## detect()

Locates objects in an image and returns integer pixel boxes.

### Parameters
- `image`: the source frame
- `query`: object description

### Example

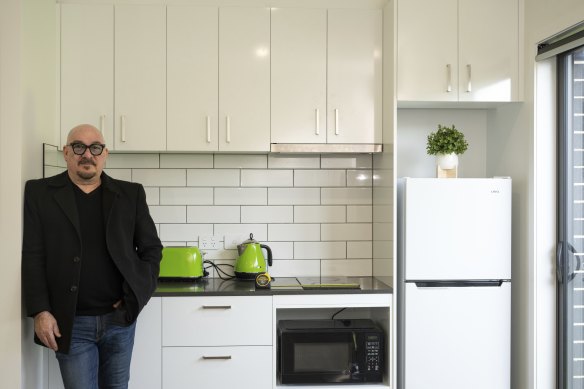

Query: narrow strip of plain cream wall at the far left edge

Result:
[0,0,22,388]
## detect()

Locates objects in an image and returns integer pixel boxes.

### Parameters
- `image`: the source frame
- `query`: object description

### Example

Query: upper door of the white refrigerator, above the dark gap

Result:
[400,178,511,280]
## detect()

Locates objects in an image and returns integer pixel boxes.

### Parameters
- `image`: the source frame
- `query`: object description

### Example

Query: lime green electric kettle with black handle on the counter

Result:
[234,234,272,280]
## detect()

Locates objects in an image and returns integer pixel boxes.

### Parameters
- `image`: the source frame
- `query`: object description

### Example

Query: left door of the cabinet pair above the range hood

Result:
[271,8,326,143]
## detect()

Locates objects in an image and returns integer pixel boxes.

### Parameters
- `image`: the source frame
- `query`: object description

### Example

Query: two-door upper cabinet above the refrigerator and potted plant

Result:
[397,0,519,102]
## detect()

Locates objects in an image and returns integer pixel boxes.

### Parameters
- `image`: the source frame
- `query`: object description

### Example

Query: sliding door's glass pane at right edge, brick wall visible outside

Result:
[556,46,584,389]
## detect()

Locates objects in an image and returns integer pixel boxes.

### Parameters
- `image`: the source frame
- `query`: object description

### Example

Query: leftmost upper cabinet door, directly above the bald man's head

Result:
[61,4,114,148]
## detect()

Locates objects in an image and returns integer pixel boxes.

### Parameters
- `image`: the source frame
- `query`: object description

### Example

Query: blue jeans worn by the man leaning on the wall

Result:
[55,313,136,389]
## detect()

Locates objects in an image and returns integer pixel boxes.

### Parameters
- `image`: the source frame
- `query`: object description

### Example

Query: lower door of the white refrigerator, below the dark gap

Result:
[398,282,511,389]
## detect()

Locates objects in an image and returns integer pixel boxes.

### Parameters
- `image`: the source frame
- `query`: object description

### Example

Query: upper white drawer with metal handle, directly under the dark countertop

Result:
[162,296,272,346]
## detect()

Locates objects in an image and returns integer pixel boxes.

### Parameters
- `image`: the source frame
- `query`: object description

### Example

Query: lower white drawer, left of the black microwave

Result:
[162,346,272,389]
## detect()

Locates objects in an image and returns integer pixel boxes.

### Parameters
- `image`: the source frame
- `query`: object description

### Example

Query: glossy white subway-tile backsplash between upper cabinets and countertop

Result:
[43,153,374,277]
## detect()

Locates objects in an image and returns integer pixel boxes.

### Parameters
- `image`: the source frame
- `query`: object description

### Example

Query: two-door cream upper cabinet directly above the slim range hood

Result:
[271,8,382,143]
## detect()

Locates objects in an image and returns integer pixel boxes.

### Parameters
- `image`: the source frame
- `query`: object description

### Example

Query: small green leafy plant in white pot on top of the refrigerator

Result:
[426,124,468,170]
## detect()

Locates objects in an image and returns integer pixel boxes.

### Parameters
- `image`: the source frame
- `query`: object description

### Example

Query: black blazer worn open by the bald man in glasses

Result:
[22,171,162,353]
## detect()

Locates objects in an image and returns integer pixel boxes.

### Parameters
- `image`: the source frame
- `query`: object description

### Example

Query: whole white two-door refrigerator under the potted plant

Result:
[397,178,511,389]
